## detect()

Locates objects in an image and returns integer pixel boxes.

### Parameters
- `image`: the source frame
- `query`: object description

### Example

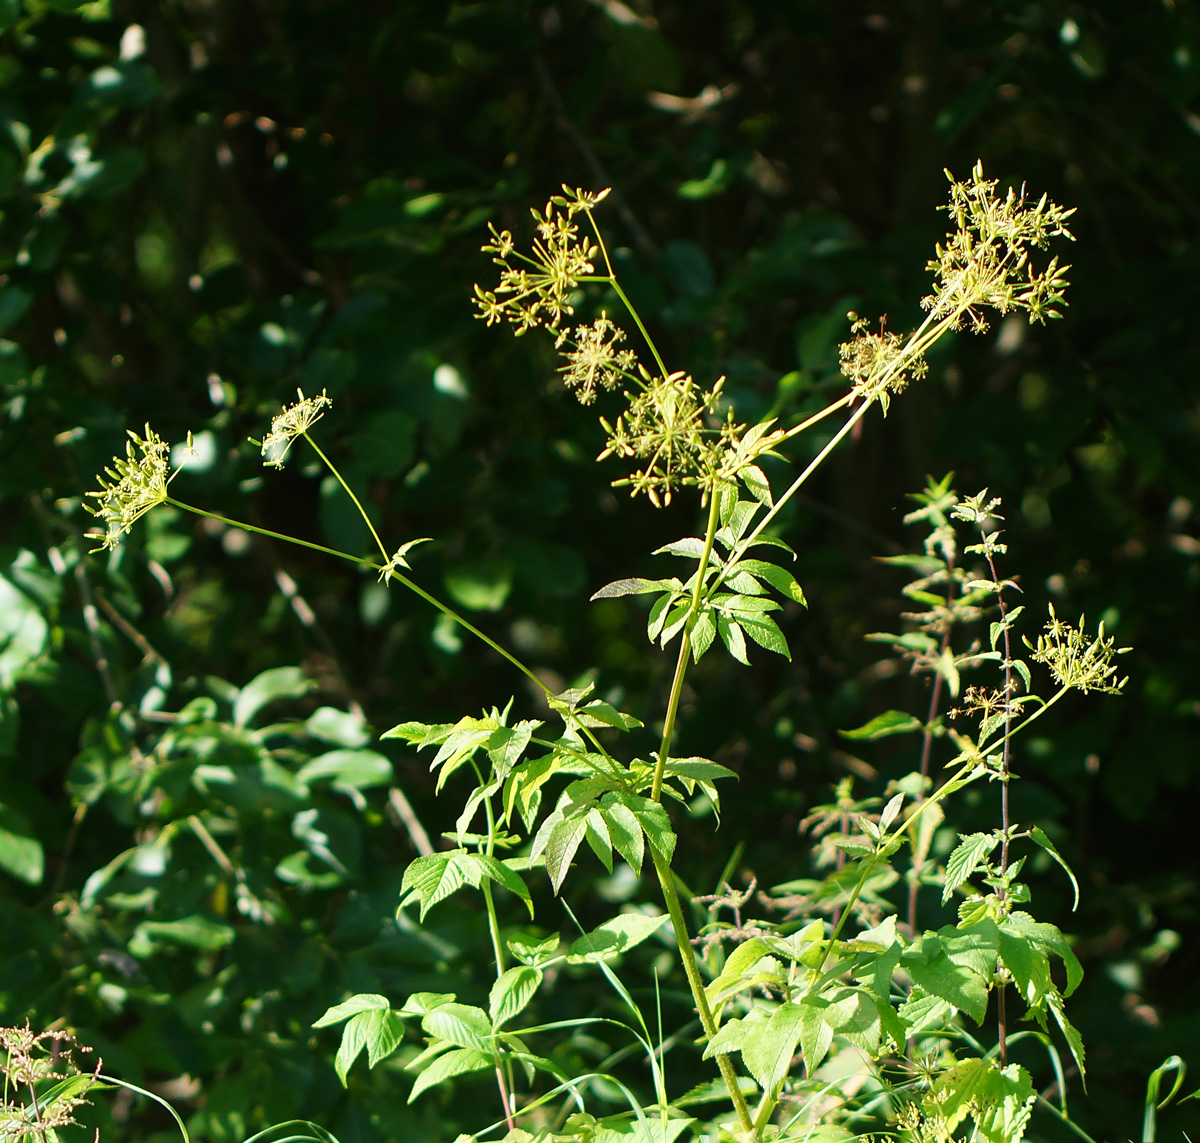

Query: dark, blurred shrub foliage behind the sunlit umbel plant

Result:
[0,0,1200,1143]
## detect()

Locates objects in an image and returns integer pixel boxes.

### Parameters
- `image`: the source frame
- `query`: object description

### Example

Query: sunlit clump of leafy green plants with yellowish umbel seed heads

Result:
[79,164,1123,1143]
